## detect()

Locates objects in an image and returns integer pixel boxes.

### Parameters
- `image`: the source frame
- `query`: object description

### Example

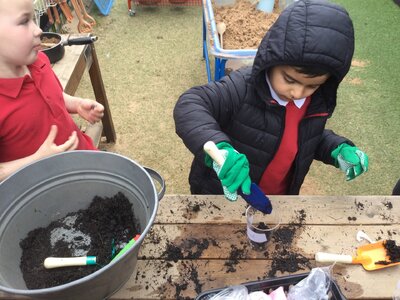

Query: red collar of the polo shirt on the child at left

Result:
[0,55,46,98]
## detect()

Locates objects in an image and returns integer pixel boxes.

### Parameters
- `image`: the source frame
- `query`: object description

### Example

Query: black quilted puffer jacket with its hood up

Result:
[174,0,354,195]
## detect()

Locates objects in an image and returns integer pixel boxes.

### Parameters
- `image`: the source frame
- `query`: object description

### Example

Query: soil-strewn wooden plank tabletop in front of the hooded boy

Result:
[111,195,400,300]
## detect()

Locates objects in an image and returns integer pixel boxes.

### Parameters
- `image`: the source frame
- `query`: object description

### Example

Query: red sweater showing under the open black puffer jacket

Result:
[259,97,310,195]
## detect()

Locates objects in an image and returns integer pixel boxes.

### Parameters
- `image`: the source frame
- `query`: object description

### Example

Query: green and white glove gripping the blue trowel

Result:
[205,142,251,200]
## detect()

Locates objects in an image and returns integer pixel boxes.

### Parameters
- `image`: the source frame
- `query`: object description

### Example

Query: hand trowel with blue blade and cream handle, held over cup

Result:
[203,141,272,214]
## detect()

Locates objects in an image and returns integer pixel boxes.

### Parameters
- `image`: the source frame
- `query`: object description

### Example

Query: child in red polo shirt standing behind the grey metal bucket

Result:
[0,0,104,180]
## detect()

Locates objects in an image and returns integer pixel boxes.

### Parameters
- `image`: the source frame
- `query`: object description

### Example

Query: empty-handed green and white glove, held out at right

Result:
[331,143,368,181]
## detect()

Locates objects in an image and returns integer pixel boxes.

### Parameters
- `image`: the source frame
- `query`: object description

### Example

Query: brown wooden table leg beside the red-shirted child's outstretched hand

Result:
[89,44,117,143]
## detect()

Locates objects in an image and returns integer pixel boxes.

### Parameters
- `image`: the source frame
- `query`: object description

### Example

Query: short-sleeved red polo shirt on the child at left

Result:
[0,52,96,162]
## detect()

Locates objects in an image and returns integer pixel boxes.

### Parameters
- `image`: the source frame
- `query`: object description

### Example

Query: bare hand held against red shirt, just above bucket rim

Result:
[34,125,79,159]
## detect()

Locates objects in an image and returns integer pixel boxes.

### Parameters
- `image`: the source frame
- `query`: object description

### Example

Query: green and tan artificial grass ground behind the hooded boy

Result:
[77,0,400,195]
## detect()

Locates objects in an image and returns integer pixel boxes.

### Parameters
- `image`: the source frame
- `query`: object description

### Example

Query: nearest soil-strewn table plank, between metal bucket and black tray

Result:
[111,260,305,300]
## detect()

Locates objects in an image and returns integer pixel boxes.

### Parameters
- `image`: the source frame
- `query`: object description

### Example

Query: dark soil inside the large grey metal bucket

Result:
[20,193,140,289]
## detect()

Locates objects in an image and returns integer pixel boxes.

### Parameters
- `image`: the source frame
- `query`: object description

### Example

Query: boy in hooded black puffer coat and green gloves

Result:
[174,0,368,195]
